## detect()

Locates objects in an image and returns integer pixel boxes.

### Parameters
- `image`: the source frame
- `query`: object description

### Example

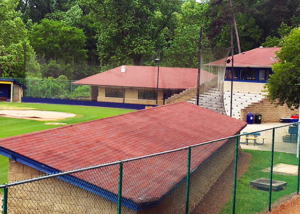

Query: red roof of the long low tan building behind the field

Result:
[73,63,217,89]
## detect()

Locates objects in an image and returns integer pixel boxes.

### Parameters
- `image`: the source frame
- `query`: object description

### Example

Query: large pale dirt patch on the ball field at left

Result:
[0,110,76,121]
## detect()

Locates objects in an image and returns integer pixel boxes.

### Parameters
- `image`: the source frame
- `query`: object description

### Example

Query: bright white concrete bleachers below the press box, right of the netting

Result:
[224,91,265,119]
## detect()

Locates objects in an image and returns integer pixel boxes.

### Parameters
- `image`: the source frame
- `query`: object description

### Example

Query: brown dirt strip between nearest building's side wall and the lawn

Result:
[191,152,252,214]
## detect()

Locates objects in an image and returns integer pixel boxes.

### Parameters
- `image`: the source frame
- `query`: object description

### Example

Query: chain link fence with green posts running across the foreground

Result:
[0,123,299,214]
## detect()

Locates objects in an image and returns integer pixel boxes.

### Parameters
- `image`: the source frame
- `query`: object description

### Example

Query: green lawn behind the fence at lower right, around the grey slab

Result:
[220,150,298,214]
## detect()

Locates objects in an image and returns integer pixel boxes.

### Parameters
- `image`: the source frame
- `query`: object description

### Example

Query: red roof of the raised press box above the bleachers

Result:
[208,47,281,68]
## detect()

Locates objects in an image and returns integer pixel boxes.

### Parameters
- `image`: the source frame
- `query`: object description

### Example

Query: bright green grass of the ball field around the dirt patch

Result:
[0,103,135,184]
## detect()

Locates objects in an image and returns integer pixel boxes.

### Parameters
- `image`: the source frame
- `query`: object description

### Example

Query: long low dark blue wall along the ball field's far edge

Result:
[22,97,155,110]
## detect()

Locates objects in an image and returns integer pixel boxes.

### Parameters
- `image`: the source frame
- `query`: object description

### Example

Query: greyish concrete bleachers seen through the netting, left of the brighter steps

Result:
[188,88,226,114]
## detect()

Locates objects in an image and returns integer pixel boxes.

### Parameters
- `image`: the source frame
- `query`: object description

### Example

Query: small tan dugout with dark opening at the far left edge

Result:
[0,78,26,102]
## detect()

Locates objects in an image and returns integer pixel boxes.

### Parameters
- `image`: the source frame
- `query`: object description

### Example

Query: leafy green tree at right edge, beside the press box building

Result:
[267,28,300,109]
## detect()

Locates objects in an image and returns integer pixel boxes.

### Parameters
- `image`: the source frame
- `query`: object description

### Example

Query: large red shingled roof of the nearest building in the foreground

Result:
[0,103,246,203]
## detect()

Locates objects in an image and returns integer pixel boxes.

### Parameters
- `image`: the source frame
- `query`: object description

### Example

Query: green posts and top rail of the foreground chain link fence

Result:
[0,123,300,214]
